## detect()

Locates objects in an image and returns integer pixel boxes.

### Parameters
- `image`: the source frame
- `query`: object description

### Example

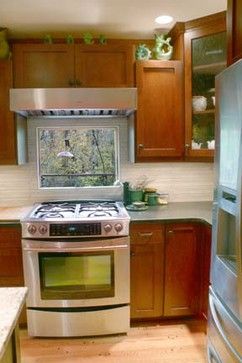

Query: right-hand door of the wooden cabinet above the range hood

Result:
[75,44,133,87]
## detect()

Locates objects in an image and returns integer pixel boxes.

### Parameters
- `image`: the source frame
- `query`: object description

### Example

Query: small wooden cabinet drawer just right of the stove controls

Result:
[130,223,164,244]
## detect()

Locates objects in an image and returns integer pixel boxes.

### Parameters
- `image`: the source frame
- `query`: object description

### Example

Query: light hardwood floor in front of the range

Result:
[20,320,206,363]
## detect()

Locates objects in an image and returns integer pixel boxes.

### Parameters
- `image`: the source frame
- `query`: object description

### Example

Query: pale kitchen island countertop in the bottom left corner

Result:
[0,287,27,359]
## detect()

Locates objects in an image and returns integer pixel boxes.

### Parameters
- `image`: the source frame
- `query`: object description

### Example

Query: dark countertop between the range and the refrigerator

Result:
[128,202,212,225]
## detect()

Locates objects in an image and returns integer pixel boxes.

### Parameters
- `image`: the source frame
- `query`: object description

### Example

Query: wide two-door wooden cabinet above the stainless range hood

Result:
[13,43,133,88]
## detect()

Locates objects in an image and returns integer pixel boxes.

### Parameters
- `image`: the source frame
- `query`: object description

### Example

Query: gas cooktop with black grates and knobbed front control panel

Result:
[21,200,130,238]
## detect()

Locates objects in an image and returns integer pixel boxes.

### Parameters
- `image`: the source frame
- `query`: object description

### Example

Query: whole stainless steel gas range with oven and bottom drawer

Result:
[21,200,130,337]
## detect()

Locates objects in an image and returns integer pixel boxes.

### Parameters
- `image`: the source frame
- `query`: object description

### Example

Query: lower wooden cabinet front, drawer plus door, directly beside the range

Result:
[130,223,164,319]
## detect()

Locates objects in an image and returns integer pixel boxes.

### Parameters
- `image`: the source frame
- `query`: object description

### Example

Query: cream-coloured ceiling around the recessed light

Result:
[0,0,227,39]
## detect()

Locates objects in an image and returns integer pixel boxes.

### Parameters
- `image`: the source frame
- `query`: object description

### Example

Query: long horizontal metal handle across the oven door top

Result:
[24,244,129,253]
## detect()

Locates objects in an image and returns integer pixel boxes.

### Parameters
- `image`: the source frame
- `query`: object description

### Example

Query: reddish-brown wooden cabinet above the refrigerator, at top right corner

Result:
[227,0,242,65]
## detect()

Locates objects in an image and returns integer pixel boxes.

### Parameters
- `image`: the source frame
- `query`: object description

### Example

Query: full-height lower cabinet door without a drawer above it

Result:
[164,224,200,316]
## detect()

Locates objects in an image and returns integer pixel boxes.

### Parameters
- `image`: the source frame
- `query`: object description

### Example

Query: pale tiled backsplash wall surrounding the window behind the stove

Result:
[0,119,213,206]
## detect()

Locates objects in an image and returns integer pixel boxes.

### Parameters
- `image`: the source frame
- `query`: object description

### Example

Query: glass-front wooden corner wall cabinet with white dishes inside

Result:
[185,19,227,161]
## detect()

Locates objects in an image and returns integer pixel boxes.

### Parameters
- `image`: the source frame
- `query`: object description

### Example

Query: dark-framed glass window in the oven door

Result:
[39,251,114,300]
